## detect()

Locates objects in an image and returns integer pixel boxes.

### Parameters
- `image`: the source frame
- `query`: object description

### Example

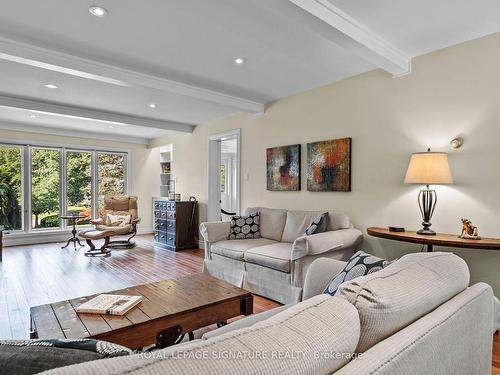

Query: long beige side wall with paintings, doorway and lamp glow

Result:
[153,34,500,295]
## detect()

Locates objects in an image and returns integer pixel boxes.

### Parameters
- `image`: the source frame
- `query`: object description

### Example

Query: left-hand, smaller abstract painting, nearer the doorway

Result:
[266,145,300,191]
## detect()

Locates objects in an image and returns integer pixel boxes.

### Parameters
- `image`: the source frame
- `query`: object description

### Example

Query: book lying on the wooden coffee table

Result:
[75,294,142,315]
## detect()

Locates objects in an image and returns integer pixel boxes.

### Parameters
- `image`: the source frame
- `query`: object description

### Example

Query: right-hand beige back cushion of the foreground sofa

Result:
[335,253,469,352]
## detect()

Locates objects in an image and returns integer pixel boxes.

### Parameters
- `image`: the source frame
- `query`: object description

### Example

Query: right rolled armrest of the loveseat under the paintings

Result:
[291,228,363,260]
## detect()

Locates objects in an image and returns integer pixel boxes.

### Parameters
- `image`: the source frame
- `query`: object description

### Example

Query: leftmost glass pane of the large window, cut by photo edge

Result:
[0,145,23,230]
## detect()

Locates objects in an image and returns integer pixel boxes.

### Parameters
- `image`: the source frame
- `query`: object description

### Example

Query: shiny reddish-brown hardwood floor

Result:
[0,235,500,375]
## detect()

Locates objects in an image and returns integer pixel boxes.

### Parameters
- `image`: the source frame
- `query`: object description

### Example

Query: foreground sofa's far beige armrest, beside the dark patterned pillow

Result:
[302,258,346,301]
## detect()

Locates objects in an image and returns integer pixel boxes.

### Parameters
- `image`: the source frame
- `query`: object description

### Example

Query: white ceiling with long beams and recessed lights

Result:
[0,0,500,142]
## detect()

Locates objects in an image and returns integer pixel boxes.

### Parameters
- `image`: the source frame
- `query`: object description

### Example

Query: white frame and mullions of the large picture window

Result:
[0,138,131,236]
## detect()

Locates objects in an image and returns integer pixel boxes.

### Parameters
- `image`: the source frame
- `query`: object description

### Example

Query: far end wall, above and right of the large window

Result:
[0,130,160,232]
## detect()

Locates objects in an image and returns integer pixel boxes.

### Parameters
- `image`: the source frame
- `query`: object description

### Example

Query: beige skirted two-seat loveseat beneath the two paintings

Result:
[200,207,363,304]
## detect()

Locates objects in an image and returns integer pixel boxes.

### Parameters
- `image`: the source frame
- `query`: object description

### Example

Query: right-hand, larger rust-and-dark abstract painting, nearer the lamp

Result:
[307,138,351,191]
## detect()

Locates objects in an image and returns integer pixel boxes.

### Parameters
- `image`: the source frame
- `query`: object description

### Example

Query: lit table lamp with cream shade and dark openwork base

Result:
[405,148,453,235]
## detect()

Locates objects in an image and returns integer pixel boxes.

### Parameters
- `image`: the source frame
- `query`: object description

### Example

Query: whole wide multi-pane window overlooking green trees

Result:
[0,144,128,232]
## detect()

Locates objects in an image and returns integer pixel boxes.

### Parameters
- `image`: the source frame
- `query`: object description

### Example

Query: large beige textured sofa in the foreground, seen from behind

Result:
[43,253,497,375]
